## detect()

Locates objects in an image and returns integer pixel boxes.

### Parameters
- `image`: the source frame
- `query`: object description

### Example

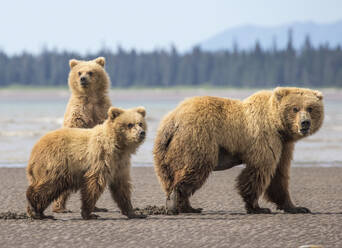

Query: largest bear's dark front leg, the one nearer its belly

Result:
[237,165,272,214]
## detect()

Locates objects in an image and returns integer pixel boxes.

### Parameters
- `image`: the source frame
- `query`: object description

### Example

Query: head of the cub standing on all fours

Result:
[106,107,147,149]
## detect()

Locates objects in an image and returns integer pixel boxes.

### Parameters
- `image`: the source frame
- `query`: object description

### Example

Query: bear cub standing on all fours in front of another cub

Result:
[26,107,147,219]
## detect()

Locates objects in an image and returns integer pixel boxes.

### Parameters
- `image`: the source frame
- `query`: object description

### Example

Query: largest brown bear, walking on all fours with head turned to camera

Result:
[154,87,324,213]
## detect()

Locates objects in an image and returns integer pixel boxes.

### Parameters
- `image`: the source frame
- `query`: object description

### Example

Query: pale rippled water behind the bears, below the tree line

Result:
[0,89,342,167]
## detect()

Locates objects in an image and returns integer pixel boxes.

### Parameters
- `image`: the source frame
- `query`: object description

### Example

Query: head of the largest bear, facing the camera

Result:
[273,87,324,140]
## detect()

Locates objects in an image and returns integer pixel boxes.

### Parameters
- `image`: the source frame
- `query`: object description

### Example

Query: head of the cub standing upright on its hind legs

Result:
[69,57,109,95]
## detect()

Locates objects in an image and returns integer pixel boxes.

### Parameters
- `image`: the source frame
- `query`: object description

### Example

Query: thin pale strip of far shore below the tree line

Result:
[0,86,342,101]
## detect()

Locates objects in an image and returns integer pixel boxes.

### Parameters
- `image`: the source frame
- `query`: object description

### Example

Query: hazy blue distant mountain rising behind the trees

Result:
[198,20,342,51]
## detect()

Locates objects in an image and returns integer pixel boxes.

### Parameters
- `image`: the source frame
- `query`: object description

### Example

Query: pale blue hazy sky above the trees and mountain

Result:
[0,0,342,54]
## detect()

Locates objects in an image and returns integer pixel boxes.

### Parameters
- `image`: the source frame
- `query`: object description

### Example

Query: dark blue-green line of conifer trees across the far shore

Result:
[0,35,342,87]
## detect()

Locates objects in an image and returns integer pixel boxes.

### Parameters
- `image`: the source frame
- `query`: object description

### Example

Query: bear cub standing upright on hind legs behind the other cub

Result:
[52,57,111,213]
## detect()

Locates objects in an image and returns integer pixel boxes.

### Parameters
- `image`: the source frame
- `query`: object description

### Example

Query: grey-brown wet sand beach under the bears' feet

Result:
[0,167,342,247]
